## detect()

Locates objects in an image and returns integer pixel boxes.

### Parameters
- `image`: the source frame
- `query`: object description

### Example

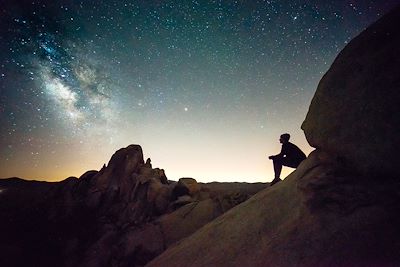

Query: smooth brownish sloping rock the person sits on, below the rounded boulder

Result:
[146,150,400,267]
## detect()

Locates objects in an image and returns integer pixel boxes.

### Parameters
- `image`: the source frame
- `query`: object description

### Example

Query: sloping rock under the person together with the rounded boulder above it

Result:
[146,7,400,267]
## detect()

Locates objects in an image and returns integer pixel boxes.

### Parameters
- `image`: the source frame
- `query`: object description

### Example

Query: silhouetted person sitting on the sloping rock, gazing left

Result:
[269,133,306,185]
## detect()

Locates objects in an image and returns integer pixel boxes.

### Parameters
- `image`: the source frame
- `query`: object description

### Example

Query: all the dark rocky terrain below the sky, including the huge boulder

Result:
[0,4,400,267]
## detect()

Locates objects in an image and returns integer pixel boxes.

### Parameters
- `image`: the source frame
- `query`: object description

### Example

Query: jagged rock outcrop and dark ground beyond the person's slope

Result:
[0,145,266,267]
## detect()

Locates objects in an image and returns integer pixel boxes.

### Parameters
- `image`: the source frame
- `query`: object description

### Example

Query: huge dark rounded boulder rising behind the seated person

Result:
[302,7,400,176]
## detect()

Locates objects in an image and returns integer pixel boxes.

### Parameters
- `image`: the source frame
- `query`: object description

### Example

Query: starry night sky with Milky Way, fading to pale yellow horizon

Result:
[0,0,399,182]
